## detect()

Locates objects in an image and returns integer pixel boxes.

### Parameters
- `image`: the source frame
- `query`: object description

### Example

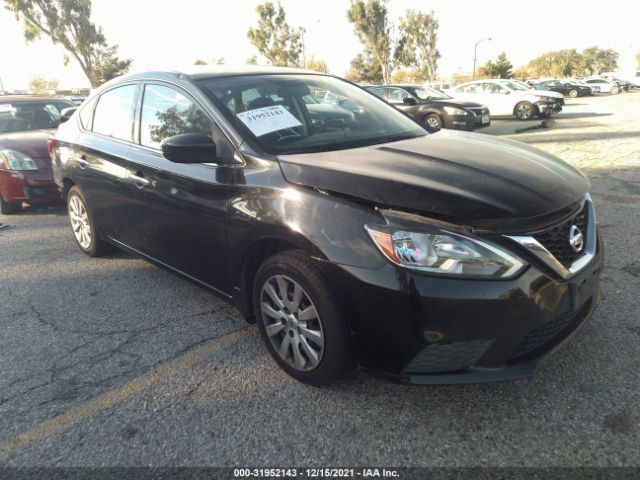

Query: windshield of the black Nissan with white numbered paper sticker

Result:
[200,74,426,154]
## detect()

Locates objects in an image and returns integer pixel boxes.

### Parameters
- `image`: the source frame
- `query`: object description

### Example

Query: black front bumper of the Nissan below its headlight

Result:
[320,231,603,384]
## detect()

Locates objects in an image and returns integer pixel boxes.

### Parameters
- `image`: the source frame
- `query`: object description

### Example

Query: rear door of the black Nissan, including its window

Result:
[69,82,139,243]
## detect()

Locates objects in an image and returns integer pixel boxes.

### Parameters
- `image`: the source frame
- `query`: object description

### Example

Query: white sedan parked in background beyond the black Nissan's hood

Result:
[447,80,563,120]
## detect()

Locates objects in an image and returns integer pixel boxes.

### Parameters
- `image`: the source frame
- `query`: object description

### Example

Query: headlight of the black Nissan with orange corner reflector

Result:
[365,225,525,278]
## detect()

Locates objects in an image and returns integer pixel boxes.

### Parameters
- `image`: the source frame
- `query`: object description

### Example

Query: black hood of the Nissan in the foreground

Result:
[278,130,589,226]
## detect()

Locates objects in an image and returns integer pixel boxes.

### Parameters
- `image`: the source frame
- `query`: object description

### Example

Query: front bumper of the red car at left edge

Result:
[0,170,60,203]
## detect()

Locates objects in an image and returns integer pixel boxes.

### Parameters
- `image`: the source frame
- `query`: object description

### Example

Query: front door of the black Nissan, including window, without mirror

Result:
[123,82,242,292]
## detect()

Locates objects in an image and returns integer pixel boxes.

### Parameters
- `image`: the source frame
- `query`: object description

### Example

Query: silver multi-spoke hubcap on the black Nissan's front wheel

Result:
[260,275,324,372]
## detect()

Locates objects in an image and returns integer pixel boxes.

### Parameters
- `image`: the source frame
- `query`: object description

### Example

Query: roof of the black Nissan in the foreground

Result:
[114,65,326,82]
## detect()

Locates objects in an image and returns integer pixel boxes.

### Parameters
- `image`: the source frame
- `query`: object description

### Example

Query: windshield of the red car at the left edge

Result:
[0,99,73,133]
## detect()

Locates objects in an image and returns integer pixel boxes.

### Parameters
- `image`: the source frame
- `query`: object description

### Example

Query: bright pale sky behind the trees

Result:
[0,0,640,90]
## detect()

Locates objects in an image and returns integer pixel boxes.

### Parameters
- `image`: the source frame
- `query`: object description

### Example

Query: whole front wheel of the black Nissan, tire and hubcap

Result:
[253,250,354,385]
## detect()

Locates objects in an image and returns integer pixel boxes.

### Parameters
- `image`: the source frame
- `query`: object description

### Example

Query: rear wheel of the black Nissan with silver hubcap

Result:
[67,186,113,257]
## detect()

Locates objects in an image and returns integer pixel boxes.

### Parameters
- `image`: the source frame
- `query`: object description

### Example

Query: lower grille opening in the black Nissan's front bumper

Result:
[509,299,593,362]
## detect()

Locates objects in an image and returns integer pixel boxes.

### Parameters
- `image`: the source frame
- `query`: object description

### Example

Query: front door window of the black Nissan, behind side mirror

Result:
[140,85,213,148]
